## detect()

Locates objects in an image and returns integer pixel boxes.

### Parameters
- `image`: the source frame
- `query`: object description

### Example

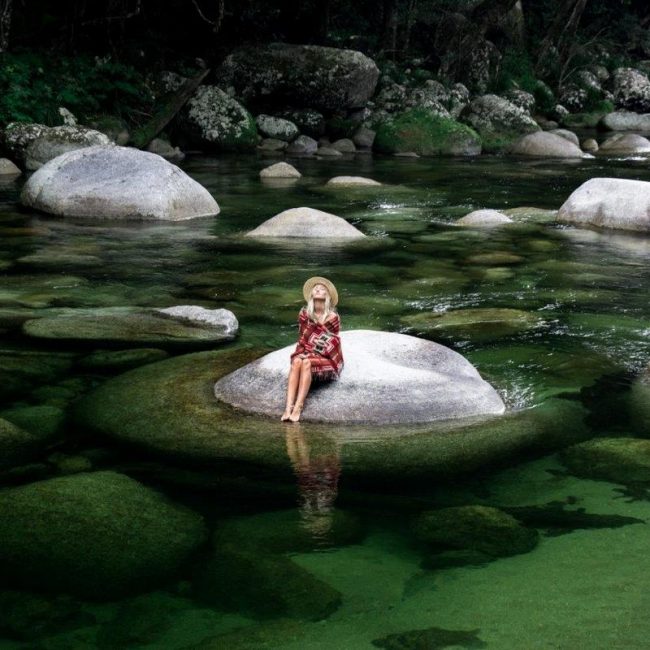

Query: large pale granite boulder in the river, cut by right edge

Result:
[557,178,650,232]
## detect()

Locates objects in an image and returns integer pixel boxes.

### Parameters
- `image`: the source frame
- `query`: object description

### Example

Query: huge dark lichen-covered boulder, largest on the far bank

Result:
[217,43,379,111]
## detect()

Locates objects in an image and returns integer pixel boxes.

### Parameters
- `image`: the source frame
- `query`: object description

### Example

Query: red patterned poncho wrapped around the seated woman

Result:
[291,307,343,381]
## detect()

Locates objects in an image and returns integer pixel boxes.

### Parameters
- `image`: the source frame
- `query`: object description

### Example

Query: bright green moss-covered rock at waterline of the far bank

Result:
[374,108,481,156]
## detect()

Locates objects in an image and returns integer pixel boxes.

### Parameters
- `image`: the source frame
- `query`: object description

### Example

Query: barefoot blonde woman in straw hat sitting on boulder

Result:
[280,277,343,422]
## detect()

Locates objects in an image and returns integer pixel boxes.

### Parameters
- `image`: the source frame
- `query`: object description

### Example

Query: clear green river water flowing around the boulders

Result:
[0,151,650,650]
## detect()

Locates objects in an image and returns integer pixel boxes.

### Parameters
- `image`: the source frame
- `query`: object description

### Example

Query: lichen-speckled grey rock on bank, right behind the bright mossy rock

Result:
[461,95,540,151]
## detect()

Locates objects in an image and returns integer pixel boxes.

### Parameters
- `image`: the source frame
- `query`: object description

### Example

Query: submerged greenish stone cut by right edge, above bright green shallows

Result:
[559,438,650,483]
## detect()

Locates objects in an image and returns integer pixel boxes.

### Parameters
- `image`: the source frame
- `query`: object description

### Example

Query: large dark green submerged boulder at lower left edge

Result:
[0,471,206,600]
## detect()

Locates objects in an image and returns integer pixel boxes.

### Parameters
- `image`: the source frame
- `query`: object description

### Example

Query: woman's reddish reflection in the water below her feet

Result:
[286,422,341,541]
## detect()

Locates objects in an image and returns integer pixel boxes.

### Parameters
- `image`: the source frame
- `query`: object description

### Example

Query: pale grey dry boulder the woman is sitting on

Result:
[214,330,505,423]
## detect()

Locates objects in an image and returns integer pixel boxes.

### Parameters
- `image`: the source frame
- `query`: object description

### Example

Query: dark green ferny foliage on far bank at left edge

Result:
[0,51,153,126]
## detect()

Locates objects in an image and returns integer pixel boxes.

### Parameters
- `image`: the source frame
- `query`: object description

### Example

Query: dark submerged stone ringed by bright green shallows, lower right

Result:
[413,505,539,557]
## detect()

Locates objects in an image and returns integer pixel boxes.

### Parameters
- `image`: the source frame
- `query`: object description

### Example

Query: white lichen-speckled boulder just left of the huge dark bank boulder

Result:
[178,86,257,151]
